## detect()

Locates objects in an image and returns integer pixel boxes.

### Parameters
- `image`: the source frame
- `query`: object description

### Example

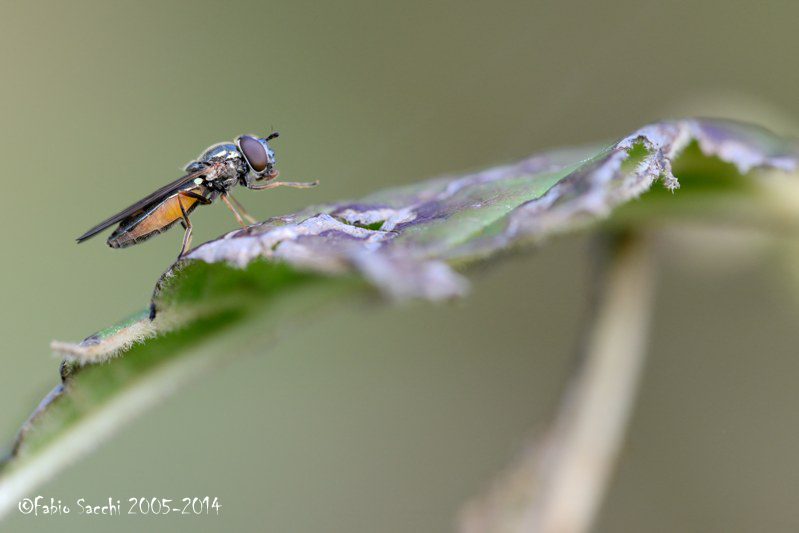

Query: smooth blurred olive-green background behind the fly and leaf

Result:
[0,0,799,532]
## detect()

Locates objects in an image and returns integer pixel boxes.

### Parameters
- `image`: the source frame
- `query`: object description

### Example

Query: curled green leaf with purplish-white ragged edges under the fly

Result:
[0,119,799,515]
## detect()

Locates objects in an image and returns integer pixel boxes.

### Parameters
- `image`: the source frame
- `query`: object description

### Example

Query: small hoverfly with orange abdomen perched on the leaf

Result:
[77,132,318,259]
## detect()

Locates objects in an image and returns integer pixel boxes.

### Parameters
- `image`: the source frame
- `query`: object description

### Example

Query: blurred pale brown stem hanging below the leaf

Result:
[462,234,654,533]
